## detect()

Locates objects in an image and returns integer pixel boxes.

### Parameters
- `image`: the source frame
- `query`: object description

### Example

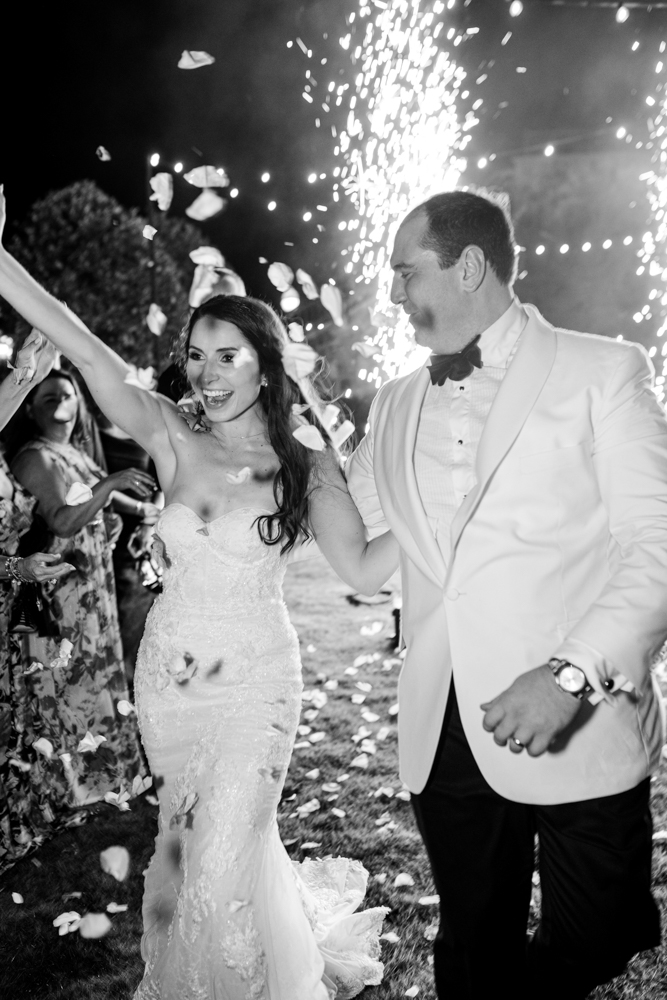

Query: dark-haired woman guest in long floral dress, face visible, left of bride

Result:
[12,371,154,814]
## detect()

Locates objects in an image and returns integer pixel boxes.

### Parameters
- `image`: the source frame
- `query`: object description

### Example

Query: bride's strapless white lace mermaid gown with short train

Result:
[135,503,387,1000]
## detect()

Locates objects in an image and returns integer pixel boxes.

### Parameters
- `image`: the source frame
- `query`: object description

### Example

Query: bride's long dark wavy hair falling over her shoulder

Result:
[176,295,342,552]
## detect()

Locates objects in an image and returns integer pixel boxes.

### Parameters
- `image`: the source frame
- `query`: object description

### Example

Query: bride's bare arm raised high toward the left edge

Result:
[0,187,175,456]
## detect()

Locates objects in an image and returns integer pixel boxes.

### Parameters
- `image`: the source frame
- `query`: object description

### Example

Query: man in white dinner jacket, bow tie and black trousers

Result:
[348,191,667,1000]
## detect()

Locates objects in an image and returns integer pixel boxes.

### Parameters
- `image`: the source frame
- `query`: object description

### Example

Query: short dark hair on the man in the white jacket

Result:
[404,191,517,285]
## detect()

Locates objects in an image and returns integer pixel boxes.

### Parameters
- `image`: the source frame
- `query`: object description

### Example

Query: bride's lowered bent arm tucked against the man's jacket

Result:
[309,449,398,594]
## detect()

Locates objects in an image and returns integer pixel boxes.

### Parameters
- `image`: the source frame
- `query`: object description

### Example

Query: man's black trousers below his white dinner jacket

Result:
[412,684,660,1000]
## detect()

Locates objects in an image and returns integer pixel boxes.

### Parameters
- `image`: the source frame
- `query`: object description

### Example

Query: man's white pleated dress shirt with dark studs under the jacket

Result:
[414,299,528,563]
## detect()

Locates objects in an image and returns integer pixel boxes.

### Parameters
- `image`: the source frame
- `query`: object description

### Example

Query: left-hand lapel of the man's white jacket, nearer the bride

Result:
[374,368,446,587]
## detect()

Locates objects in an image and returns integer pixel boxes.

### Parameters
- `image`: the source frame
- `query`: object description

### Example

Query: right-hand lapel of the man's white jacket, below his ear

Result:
[451,306,556,552]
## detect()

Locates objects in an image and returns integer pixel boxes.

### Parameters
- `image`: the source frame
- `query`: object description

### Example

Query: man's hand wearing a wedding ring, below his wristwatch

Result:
[480,664,581,757]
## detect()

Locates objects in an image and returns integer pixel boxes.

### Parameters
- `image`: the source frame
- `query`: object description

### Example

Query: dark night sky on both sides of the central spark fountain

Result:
[0,0,667,293]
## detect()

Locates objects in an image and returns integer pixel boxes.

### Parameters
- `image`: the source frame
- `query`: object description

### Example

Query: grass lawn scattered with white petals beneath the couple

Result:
[0,558,667,1000]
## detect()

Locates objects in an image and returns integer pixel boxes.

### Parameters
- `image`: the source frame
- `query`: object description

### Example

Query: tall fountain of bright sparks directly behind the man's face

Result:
[329,0,476,381]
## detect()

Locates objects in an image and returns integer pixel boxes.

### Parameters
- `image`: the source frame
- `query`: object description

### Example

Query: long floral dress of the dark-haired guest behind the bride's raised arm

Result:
[0,438,146,864]
